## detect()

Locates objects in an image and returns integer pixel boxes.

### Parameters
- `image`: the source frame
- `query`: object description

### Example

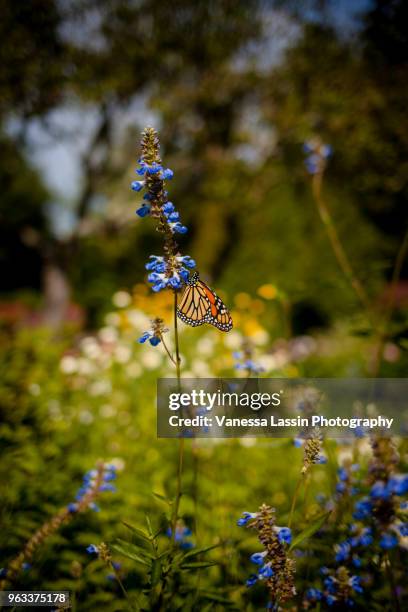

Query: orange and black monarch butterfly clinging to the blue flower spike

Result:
[177,272,232,331]
